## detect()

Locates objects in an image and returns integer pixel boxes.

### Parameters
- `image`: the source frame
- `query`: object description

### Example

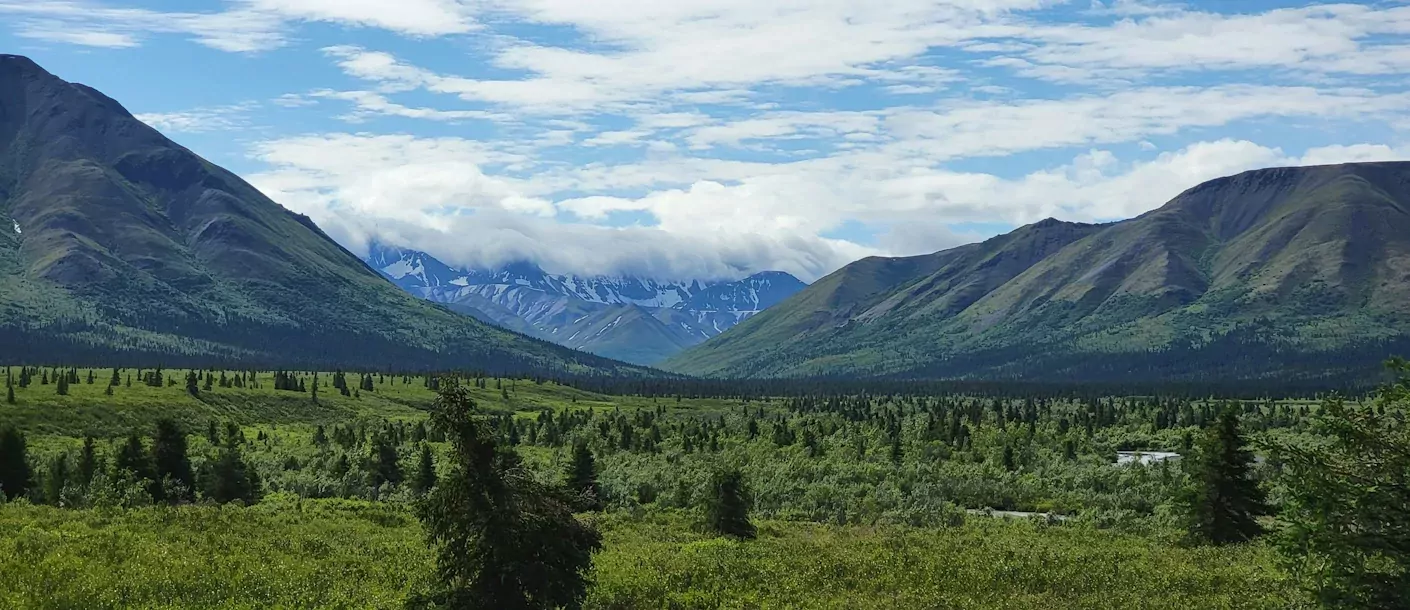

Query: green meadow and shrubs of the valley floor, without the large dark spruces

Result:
[0,369,1331,609]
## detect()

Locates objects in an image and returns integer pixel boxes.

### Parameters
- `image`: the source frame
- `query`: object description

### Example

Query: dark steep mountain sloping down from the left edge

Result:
[0,55,640,373]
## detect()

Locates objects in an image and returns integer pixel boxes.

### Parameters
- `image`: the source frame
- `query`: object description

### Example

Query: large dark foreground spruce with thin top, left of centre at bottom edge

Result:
[412,379,602,610]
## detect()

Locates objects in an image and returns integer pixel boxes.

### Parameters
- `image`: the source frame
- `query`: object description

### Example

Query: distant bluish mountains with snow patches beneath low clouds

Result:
[365,244,805,365]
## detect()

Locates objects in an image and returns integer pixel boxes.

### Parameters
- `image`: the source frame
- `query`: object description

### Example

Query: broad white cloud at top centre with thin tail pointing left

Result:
[320,0,1049,113]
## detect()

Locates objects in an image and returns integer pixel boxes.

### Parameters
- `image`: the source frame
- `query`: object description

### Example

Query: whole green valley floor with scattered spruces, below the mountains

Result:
[0,361,1410,609]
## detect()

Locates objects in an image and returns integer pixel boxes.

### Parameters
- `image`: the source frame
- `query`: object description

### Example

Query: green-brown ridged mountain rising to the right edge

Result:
[663,162,1410,380]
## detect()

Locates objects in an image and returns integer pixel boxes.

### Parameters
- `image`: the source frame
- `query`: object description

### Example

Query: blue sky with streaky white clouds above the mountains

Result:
[0,0,1410,280]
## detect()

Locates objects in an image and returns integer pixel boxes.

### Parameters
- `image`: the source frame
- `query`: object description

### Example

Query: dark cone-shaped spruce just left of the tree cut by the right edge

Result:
[1179,406,1268,544]
